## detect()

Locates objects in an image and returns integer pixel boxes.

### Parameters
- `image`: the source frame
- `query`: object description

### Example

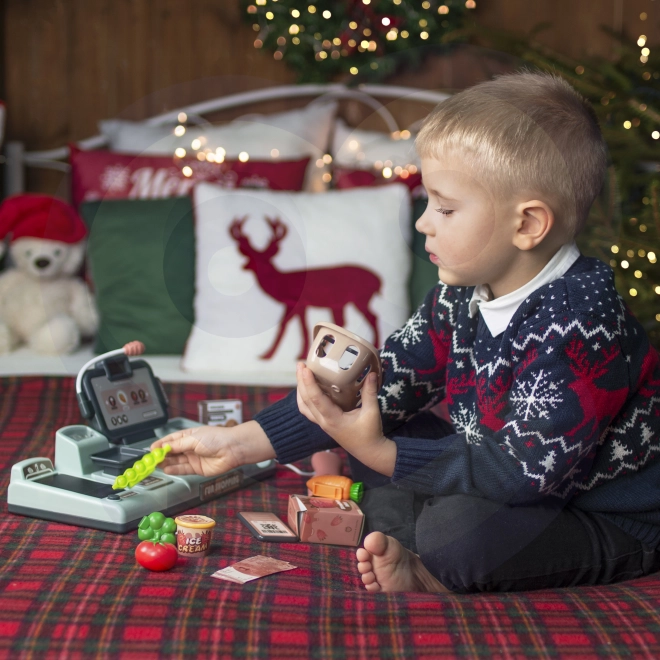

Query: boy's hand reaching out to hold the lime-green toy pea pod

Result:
[151,421,275,477]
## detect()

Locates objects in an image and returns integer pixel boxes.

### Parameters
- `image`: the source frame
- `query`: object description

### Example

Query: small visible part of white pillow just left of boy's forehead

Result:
[332,119,420,170]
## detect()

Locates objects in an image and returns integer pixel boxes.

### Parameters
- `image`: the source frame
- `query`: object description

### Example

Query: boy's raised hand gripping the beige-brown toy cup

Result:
[296,363,396,476]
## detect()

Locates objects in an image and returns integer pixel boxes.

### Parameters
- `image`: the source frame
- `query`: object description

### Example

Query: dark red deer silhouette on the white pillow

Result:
[229,216,381,360]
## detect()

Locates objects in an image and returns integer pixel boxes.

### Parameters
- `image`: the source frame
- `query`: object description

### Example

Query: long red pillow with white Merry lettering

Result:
[70,146,309,207]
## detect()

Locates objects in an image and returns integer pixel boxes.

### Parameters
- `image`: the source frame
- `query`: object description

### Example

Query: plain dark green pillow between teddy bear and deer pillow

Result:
[80,197,195,355]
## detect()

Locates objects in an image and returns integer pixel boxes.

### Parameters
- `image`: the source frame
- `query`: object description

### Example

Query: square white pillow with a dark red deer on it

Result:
[182,183,411,385]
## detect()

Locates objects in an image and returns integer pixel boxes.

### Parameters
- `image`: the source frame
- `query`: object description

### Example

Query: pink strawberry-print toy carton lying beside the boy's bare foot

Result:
[288,495,364,546]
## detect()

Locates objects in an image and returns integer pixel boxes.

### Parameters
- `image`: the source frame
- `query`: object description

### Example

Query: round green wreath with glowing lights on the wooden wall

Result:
[243,0,476,83]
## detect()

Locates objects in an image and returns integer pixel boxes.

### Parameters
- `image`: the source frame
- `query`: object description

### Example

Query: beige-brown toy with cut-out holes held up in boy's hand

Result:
[307,323,383,412]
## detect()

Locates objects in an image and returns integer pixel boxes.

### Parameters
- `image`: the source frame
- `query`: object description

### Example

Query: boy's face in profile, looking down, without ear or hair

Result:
[415,158,518,296]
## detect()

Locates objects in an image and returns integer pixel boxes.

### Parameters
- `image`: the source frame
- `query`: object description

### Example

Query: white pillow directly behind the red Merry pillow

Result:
[99,102,337,191]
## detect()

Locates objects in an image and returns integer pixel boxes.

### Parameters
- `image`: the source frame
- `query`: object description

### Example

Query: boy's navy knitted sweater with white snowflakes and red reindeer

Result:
[255,256,660,547]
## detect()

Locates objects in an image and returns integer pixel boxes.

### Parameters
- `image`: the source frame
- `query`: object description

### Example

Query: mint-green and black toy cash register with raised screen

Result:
[7,342,275,533]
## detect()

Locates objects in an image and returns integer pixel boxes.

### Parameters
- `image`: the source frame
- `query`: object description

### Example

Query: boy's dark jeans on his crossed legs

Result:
[351,414,660,593]
